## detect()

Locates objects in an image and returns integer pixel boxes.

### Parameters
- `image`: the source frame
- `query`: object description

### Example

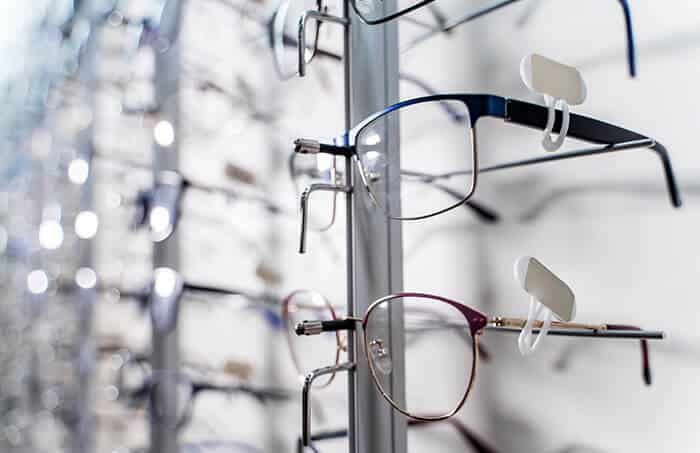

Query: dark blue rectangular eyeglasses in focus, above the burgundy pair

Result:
[294,94,681,253]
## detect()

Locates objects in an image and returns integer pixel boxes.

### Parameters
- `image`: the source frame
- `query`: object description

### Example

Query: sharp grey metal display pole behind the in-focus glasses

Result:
[345,0,406,453]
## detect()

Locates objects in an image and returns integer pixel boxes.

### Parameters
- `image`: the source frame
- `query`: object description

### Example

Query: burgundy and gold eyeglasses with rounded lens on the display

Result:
[295,293,664,445]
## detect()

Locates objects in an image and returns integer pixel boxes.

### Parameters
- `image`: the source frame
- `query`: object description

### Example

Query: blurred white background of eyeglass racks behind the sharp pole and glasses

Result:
[0,0,700,453]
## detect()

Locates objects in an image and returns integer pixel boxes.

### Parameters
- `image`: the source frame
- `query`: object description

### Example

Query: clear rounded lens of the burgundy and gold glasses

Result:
[365,296,475,418]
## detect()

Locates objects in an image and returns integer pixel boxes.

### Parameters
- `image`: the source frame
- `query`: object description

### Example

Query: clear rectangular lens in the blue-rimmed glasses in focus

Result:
[356,100,476,220]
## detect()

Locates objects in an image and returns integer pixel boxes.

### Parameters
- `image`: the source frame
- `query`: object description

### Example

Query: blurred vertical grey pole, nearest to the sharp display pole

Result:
[151,0,183,453]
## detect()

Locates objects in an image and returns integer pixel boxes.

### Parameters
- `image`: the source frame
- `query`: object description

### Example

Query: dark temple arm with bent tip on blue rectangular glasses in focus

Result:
[500,99,682,207]
